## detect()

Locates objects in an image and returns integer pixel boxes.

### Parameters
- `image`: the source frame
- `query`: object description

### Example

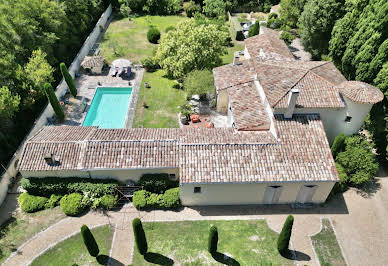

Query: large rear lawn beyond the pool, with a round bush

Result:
[101,16,187,63]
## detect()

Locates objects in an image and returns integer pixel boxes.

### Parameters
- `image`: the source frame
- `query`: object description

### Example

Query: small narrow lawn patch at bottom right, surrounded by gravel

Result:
[311,219,346,265]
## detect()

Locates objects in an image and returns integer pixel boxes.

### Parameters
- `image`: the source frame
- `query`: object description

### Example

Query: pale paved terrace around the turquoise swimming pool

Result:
[60,68,144,128]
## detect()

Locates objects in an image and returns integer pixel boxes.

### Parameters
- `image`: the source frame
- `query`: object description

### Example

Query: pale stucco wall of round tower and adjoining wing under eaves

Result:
[275,97,372,144]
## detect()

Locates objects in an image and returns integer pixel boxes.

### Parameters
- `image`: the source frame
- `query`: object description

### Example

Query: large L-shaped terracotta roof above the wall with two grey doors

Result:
[179,115,338,183]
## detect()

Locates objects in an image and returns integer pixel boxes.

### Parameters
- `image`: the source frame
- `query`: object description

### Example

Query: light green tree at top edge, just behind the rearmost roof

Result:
[278,0,308,28]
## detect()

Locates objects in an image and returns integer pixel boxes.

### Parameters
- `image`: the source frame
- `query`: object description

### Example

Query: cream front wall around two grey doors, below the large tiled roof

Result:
[180,182,335,206]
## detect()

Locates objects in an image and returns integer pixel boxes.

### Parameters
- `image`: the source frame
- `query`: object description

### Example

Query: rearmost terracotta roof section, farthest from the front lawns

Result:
[244,27,294,60]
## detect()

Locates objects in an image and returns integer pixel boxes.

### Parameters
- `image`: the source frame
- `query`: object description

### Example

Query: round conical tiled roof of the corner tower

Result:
[339,81,384,104]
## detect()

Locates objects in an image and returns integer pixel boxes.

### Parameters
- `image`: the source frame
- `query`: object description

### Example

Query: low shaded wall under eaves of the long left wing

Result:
[20,168,179,183]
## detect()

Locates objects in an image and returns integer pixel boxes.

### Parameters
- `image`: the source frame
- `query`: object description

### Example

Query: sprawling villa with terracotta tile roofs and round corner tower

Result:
[18,27,383,206]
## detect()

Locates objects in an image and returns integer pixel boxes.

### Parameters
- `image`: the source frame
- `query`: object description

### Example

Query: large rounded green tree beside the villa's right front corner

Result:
[336,135,378,185]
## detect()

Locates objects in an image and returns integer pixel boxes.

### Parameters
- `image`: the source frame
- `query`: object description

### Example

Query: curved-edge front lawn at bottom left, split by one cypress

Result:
[31,225,113,266]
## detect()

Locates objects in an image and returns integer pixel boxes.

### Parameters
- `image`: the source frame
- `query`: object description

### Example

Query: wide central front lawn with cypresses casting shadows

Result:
[133,220,293,265]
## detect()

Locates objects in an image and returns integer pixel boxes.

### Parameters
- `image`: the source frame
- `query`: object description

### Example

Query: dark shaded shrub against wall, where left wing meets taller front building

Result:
[138,174,178,194]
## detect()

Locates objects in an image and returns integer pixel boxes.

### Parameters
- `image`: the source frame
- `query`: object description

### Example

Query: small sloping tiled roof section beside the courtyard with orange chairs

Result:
[228,81,270,130]
